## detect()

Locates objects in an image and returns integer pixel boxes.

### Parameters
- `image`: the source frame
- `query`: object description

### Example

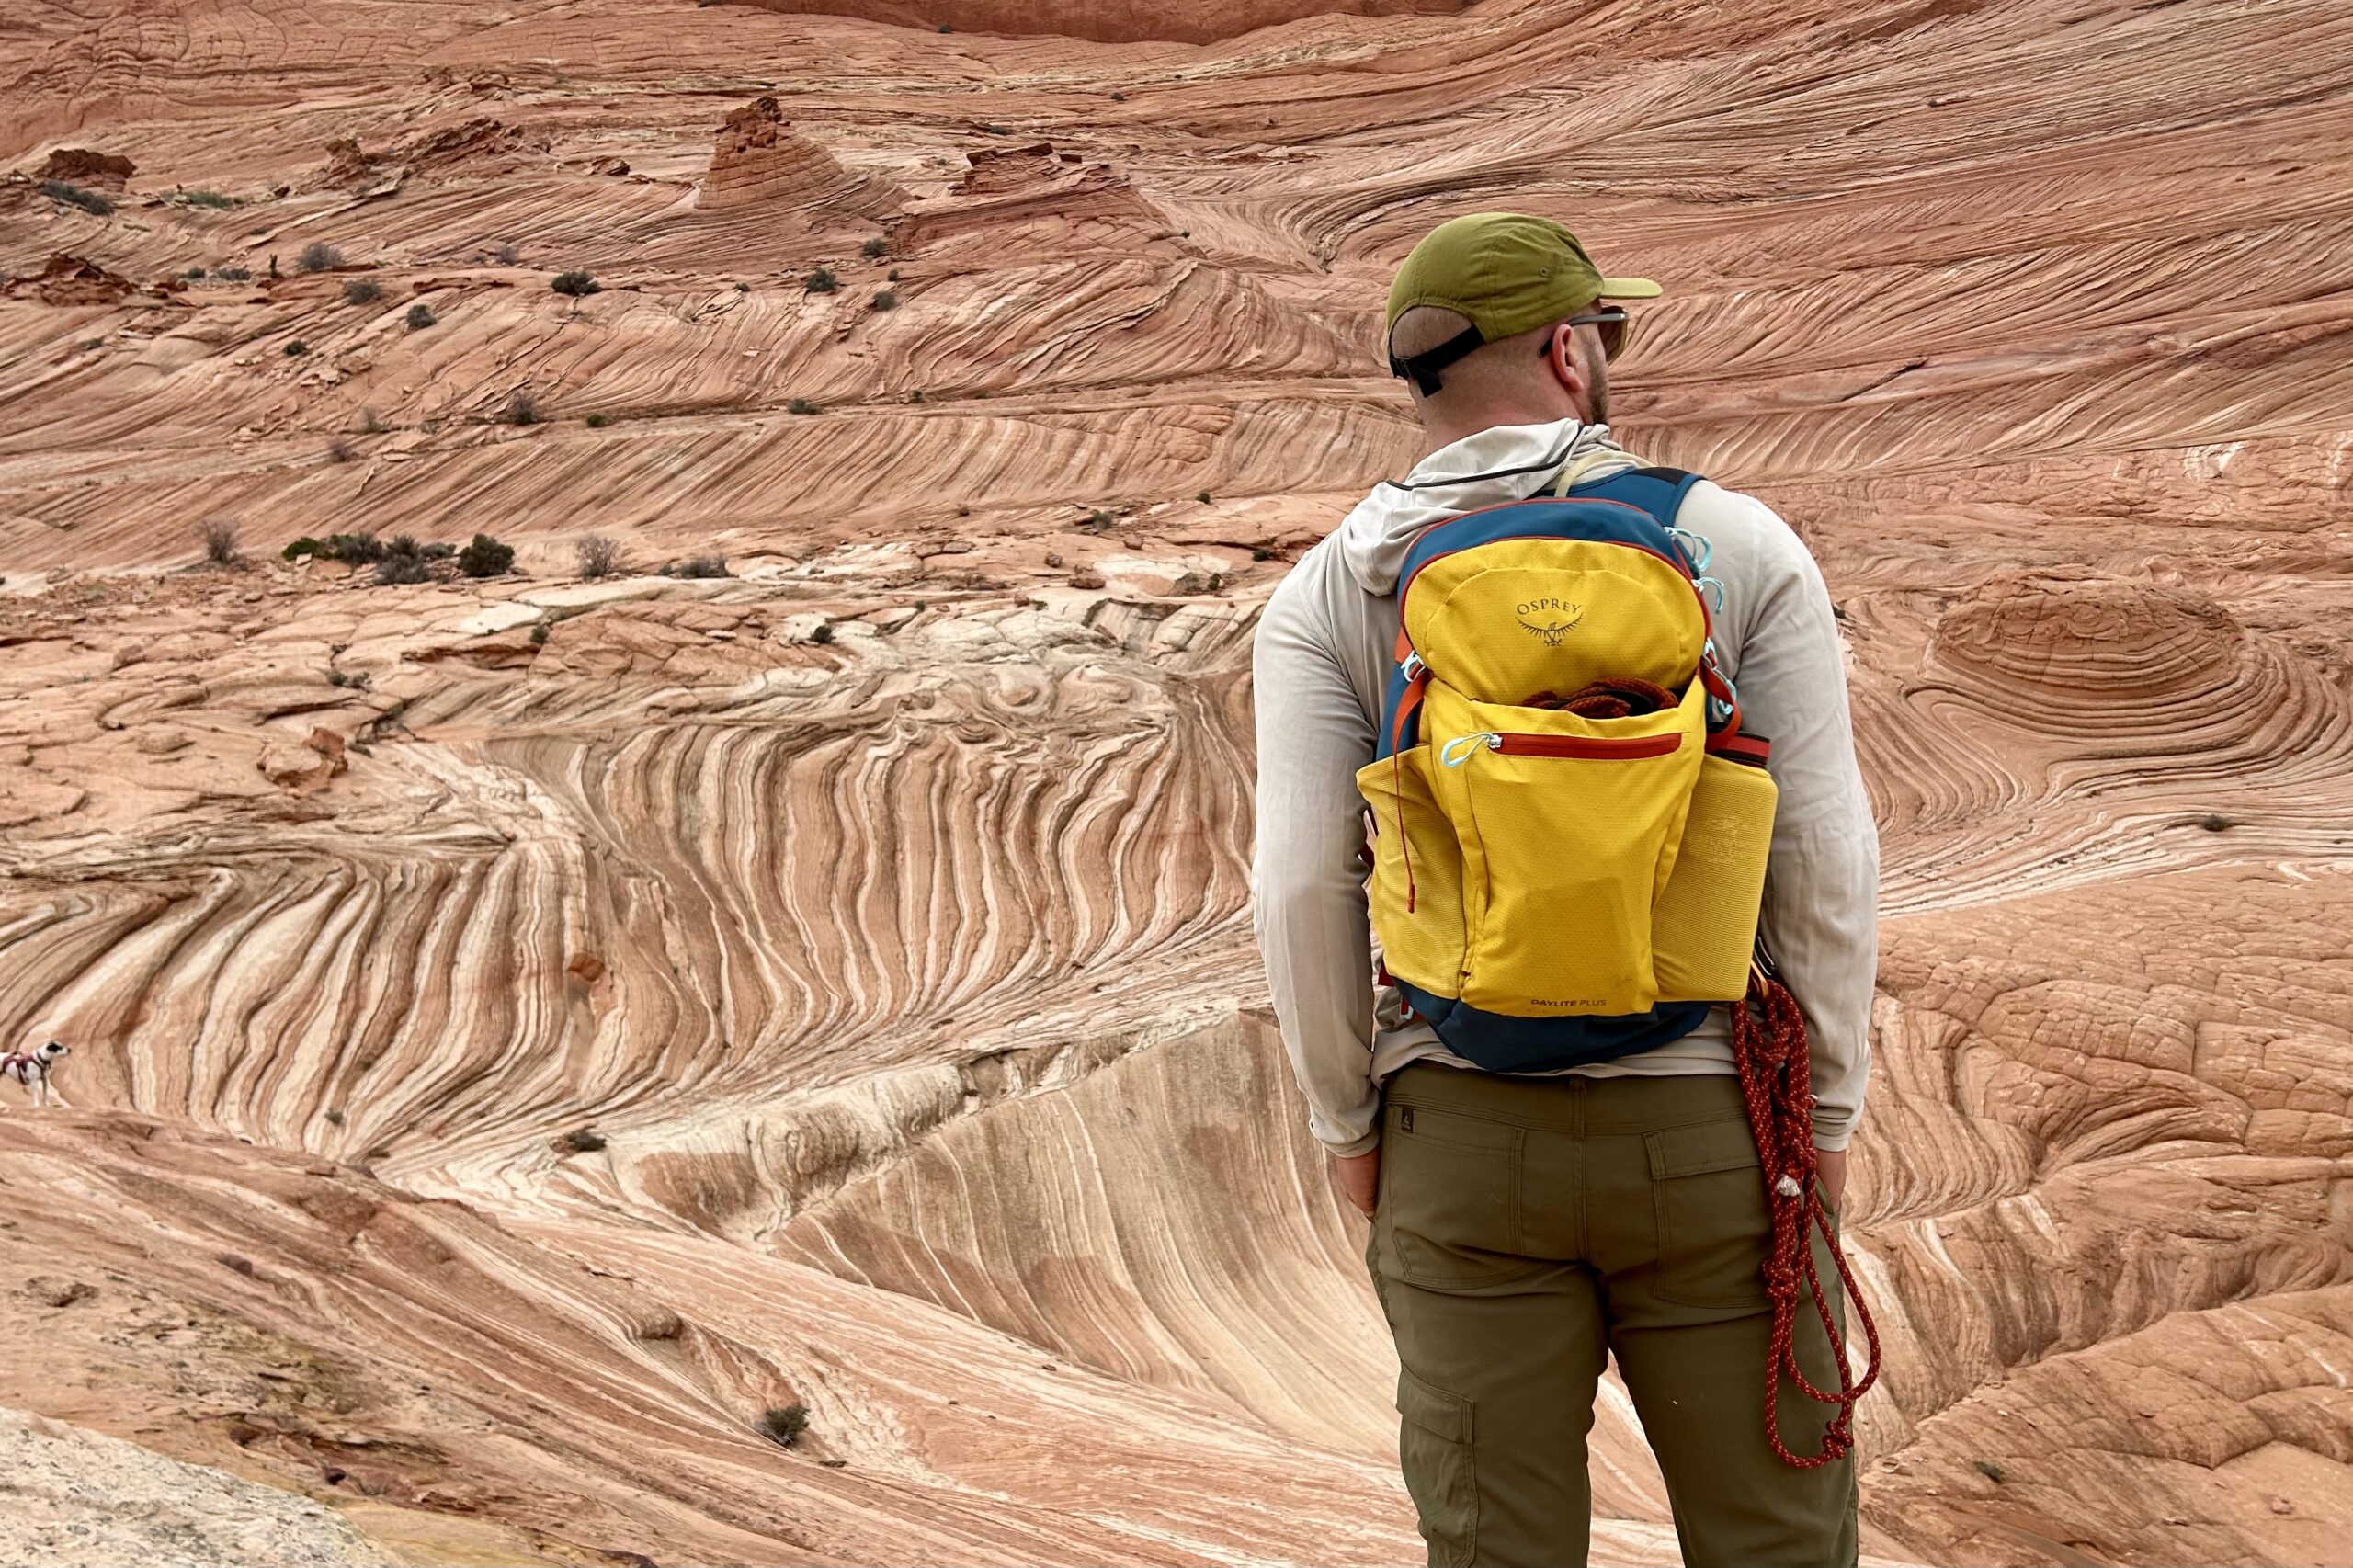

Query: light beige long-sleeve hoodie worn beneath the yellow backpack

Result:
[1252,419,1880,1153]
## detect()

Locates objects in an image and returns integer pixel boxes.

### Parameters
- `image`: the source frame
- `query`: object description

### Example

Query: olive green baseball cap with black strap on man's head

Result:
[1383,212,1664,393]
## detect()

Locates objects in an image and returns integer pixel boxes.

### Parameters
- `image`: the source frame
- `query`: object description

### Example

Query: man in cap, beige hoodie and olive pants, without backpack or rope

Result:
[1252,214,1878,1565]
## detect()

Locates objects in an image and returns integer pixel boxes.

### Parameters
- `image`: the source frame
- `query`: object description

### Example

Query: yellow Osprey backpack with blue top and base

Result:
[1358,451,1777,1072]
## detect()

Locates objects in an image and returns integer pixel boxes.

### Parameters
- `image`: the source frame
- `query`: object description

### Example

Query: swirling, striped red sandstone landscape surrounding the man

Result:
[0,0,2353,1565]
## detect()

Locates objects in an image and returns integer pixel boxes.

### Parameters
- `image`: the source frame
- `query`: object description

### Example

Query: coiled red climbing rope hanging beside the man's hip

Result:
[1732,970,1880,1469]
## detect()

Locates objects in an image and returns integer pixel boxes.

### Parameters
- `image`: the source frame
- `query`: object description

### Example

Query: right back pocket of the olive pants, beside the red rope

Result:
[1643,1120,1772,1307]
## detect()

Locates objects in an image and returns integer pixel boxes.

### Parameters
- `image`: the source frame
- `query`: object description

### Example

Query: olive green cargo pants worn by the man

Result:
[1365,1062,1857,1568]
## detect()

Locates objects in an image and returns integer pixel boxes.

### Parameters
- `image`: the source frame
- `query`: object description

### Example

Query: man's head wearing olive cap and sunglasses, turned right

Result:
[1388,212,1659,445]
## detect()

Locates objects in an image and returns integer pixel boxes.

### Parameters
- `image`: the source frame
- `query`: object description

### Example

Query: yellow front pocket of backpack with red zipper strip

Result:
[1433,680,1706,1017]
